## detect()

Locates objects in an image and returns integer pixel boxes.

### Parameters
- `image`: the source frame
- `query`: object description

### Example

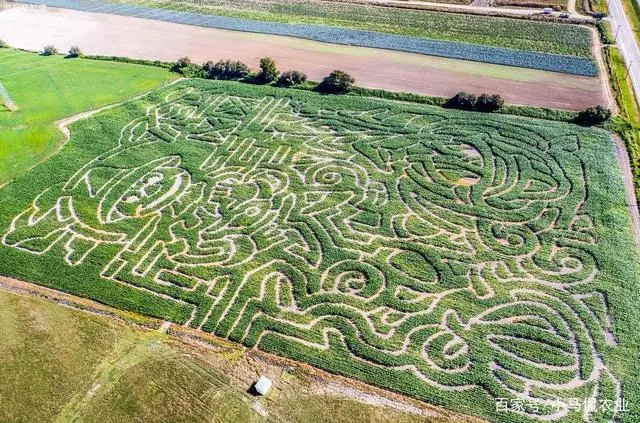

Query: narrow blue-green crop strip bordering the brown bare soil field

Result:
[21,0,597,76]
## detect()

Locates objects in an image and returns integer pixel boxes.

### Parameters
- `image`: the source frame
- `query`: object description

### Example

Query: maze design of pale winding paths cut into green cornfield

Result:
[2,88,620,419]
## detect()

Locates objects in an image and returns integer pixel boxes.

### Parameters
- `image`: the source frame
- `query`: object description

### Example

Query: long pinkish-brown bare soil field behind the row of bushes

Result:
[0,7,608,110]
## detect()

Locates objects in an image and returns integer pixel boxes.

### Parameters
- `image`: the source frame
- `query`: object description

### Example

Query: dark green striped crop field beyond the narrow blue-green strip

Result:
[107,0,592,57]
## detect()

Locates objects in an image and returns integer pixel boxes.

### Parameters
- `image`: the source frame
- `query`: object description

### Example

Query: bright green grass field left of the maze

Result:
[0,49,175,185]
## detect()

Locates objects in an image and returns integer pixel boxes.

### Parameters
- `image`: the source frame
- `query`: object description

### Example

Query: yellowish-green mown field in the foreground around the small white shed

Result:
[0,291,467,423]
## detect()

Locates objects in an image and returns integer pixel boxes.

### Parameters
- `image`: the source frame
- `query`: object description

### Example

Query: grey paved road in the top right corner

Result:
[608,0,640,99]
